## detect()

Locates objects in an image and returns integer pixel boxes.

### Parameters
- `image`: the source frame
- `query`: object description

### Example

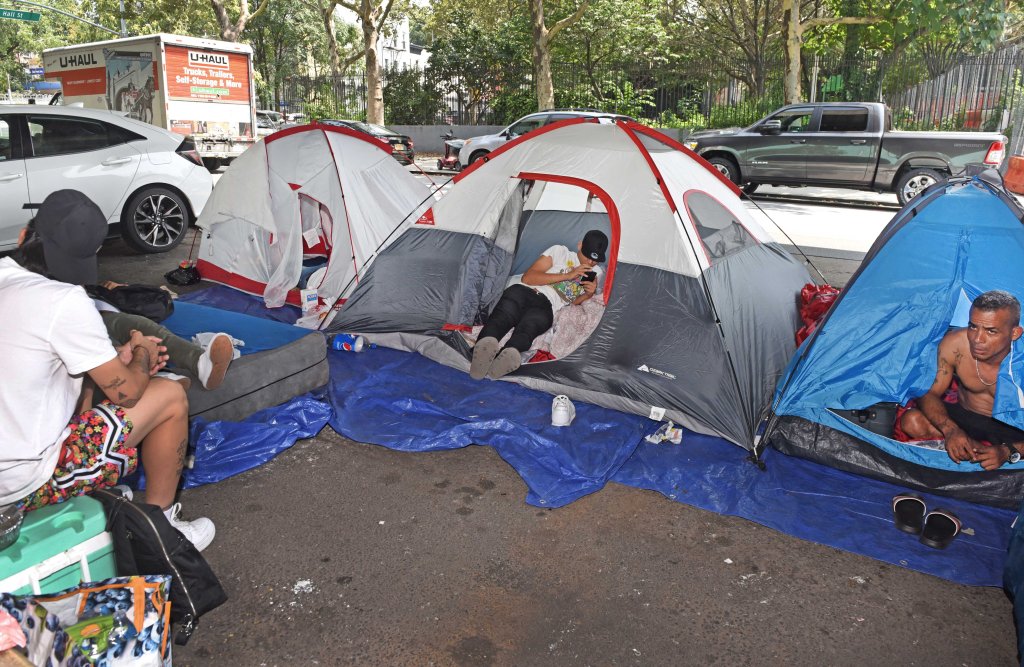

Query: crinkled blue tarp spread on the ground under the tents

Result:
[174,288,1014,586]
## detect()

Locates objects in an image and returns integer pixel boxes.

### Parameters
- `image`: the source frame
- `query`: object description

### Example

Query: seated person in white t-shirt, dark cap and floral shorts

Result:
[0,191,215,549]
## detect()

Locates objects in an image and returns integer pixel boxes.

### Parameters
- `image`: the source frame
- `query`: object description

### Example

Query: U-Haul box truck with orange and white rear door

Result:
[43,34,256,169]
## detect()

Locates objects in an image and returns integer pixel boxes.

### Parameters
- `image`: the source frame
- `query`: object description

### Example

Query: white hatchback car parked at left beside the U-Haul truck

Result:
[0,105,213,252]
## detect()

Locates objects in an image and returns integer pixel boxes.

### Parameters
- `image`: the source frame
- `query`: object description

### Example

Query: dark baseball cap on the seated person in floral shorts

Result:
[34,190,108,285]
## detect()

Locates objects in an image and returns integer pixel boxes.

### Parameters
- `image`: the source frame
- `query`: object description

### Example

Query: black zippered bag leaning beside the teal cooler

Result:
[93,489,227,645]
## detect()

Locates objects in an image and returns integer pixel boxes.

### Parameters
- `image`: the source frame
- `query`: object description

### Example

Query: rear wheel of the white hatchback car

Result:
[121,187,191,253]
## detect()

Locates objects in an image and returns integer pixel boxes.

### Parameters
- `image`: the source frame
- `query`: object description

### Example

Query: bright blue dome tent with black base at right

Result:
[760,171,1024,508]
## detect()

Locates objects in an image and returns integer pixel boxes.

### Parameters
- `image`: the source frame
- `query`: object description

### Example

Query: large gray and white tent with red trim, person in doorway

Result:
[331,119,809,448]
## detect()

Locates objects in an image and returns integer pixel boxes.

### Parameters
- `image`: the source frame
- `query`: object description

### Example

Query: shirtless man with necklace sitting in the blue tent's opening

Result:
[900,290,1024,470]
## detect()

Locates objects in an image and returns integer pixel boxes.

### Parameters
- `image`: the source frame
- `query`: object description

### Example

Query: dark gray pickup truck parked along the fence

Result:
[686,102,1007,204]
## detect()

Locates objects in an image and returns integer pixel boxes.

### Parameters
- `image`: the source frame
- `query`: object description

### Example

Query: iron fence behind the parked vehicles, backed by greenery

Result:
[272,47,1024,148]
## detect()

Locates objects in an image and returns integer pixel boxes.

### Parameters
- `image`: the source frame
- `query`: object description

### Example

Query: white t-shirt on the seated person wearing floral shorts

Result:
[0,257,117,505]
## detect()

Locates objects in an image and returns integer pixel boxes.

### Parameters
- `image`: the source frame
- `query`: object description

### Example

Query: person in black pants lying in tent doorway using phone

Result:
[469,230,608,380]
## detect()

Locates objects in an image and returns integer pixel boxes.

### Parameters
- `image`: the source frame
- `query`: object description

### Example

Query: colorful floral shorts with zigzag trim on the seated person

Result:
[17,401,138,511]
